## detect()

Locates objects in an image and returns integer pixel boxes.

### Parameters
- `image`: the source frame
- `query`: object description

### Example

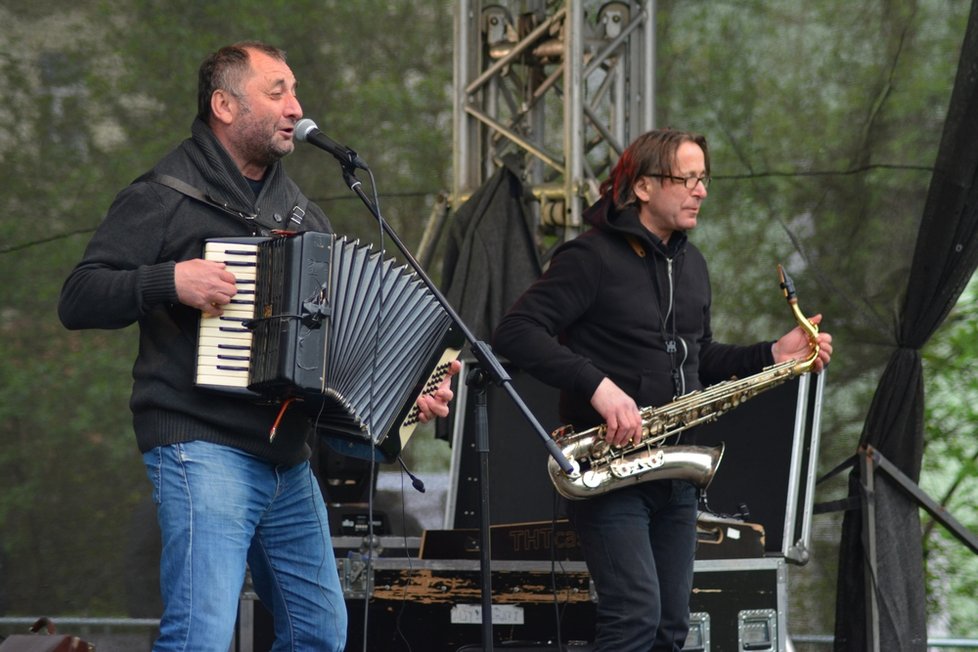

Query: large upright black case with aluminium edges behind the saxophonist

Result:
[445,362,825,563]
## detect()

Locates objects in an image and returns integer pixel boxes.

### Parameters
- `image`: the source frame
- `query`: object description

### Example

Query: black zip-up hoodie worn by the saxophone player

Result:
[493,196,774,430]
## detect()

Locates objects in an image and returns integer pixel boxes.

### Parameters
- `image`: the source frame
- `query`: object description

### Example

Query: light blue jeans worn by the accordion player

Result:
[143,441,347,652]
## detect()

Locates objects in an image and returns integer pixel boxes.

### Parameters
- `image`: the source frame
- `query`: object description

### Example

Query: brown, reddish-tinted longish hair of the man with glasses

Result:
[601,129,710,209]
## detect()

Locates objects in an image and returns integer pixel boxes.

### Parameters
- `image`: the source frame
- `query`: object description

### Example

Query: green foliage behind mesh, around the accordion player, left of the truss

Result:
[0,0,452,616]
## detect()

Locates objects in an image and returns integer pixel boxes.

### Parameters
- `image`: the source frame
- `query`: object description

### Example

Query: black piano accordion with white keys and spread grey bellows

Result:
[195,232,462,461]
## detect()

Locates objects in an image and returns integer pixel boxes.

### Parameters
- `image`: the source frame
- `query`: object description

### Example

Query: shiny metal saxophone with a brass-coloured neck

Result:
[547,265,819,500]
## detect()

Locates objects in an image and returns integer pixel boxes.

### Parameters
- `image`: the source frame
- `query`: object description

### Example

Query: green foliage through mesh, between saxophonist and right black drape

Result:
[656,0,978,632]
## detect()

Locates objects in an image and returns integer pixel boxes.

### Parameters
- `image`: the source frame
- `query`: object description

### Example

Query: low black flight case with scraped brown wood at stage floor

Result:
[328,554,787,652]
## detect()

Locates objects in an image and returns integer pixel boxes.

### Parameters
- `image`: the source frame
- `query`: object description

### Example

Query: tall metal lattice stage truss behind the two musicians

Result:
[419,0,656,260]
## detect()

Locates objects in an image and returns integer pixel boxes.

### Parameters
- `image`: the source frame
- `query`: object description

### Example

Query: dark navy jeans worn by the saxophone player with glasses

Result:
[567,480,698,652]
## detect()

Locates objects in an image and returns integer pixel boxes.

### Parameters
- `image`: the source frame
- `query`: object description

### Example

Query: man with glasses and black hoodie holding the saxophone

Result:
[493,129,832,652]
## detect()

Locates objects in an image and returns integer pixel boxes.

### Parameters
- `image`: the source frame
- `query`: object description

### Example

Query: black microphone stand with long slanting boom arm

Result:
[331,154,574,652]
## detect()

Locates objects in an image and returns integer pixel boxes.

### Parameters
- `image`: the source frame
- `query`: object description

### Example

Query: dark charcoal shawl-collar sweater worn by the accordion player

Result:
[58,120,331,464]
